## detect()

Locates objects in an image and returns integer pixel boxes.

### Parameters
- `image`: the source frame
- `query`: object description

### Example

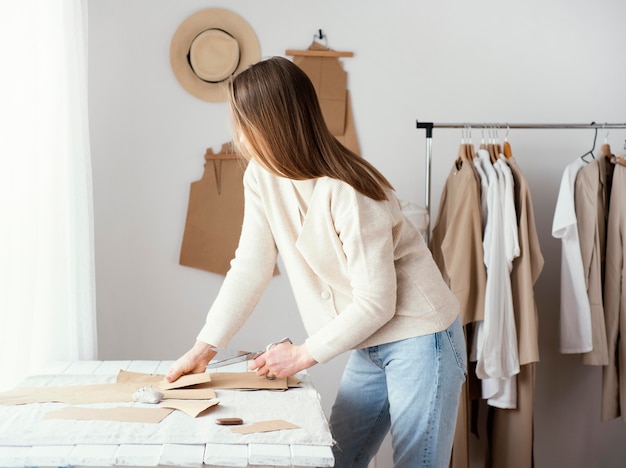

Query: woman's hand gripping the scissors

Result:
[248,343,317,378]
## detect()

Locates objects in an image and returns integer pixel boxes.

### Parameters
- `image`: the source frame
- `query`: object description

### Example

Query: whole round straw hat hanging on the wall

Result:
[170,8,261,102]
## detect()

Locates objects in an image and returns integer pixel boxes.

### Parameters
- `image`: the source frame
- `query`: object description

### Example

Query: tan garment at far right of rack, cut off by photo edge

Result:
[602,164,626,421]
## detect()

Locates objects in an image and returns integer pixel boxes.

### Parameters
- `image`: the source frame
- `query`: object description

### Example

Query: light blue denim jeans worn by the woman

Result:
[330,318,467,468]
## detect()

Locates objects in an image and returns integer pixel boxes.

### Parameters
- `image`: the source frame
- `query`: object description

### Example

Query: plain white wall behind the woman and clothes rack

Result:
[88,0,626,468]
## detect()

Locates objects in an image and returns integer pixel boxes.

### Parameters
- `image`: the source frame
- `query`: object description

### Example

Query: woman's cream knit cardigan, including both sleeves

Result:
[198,162,459,363]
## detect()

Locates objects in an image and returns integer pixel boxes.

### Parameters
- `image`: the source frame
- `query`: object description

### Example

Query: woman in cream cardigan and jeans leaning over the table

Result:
[166,57,466,468]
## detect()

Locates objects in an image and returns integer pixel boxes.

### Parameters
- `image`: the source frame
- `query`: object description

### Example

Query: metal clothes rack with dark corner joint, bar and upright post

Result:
[416,120,626,241]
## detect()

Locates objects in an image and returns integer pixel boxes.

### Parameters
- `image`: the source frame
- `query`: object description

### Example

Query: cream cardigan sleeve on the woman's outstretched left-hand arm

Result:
[197,164,278,347]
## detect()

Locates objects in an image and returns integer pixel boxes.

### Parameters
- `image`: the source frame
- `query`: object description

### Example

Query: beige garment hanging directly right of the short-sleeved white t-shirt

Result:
[575,156,614,366]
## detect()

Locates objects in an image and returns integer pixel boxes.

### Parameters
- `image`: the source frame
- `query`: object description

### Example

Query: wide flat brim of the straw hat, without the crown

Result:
[170,8,261,102]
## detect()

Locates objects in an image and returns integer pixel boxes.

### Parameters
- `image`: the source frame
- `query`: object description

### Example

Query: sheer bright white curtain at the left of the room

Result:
[0,0,97,390]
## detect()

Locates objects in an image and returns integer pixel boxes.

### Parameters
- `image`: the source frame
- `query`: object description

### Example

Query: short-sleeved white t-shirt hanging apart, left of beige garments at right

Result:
[552,158,593,354]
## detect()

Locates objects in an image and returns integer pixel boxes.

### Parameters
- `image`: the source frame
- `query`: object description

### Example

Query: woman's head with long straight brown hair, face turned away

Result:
[229,57,393,200]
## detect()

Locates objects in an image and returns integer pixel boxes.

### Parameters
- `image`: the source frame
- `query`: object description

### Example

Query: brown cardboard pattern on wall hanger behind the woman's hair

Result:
[286,41,361,155]
